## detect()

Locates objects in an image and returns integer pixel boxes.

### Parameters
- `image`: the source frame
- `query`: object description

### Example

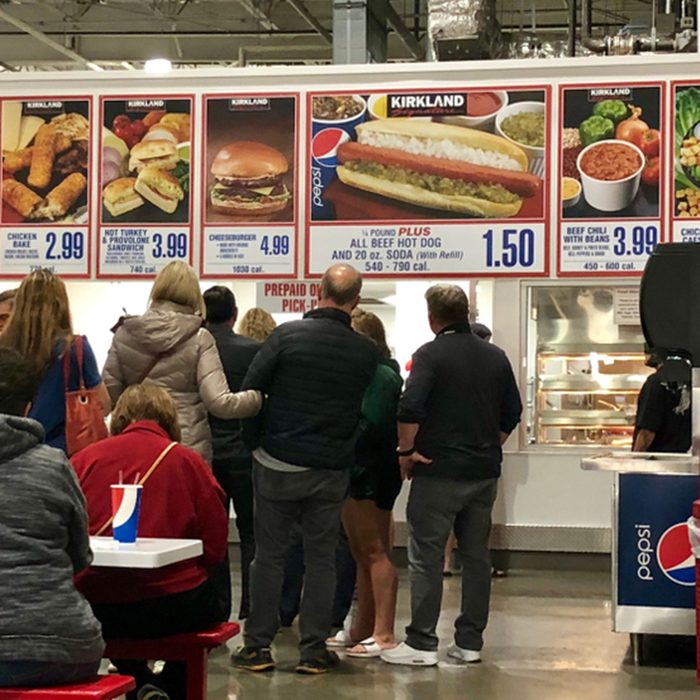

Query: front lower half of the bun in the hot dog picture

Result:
[336,165,523,219]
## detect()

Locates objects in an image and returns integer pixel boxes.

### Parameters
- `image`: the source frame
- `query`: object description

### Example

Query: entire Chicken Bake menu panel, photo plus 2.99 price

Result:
[0,96,92,278]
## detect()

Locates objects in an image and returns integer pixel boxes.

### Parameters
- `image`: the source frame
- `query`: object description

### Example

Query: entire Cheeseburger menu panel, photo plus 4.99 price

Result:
[201,93,299,279]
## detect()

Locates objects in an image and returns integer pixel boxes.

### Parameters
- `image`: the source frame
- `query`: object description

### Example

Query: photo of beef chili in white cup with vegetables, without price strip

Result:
[559,85,664,220]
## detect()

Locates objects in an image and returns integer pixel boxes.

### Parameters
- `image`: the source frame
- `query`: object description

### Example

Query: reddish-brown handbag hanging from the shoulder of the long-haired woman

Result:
[63,335,108,457]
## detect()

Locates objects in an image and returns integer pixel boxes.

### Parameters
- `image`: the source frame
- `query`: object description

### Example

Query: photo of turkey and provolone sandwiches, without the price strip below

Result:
[100,97,192,224]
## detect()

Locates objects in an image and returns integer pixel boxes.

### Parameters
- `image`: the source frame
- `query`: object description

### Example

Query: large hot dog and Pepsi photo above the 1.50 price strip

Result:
[309,90,547,221]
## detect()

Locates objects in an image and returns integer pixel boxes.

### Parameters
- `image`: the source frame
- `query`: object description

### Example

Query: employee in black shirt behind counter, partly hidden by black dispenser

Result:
[632,346,691,452]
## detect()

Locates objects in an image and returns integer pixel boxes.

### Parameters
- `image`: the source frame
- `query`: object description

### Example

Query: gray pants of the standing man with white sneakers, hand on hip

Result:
[406,476,498,651]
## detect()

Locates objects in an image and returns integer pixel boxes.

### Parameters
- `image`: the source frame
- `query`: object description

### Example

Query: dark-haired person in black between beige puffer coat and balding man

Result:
[204,287,260,620]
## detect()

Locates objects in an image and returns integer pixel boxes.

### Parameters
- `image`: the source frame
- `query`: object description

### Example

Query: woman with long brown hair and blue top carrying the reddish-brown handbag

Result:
[0,270,112,452]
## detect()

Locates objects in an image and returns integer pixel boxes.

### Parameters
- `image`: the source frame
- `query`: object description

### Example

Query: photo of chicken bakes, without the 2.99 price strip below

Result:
[0,100,90,224]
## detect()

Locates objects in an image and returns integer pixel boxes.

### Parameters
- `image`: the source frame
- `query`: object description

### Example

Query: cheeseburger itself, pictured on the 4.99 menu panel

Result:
[210,141,292,217]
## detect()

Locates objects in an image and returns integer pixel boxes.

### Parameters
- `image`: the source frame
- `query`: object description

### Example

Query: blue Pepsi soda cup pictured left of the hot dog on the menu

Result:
[309,95,367,221]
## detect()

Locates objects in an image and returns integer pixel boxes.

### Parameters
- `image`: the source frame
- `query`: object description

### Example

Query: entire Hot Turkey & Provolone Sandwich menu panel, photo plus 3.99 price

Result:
[97,95,194,277]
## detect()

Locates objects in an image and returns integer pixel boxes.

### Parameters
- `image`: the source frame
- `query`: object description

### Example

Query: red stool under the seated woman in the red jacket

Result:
[104,622,241,700]
